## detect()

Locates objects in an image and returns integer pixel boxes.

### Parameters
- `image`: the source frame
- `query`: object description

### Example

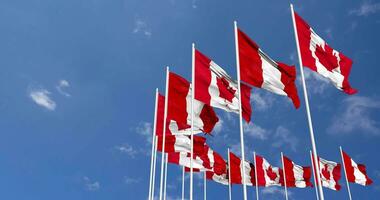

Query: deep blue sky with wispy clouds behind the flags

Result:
[0,0,380,200]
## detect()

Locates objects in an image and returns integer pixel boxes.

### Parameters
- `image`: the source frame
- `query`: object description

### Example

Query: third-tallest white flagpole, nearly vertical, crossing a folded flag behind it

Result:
[190,43,195,200]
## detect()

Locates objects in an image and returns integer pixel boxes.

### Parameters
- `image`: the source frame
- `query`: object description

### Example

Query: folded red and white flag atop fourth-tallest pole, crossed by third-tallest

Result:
[167,72,219,135]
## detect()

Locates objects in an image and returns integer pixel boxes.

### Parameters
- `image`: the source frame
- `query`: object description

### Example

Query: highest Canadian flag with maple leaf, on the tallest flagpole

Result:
[294,12,357,94]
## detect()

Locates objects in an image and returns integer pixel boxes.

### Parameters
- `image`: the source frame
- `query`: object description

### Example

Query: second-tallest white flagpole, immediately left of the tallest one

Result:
[234,21,247,200]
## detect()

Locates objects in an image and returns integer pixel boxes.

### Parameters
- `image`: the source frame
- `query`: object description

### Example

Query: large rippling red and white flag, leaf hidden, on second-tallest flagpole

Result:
[238,29,300,108]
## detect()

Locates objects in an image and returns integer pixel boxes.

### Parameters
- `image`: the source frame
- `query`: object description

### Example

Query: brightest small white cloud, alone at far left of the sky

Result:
[29,88,57,111]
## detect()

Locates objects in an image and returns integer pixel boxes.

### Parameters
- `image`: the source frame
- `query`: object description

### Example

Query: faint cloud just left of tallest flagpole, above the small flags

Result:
[272,126,298,151]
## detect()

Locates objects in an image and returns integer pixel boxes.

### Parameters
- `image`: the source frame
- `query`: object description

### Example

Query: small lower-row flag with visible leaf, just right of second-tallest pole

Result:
[256,155,284,187]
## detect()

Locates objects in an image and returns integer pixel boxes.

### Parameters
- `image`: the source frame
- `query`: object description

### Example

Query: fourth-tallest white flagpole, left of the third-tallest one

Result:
[159,67,169,200]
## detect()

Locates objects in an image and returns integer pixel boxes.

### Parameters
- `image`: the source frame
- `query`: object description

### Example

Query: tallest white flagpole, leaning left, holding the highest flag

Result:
[290,4,324,200]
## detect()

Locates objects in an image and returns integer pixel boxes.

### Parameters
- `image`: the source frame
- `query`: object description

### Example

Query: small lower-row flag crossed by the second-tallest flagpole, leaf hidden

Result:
[229,152,256,186]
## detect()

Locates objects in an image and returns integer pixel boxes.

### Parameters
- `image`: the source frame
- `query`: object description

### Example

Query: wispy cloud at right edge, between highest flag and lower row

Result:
[327,96,380,135]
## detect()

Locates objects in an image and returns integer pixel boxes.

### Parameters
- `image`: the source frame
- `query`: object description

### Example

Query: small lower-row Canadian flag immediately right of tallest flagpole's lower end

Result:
[318,157,341,190]
